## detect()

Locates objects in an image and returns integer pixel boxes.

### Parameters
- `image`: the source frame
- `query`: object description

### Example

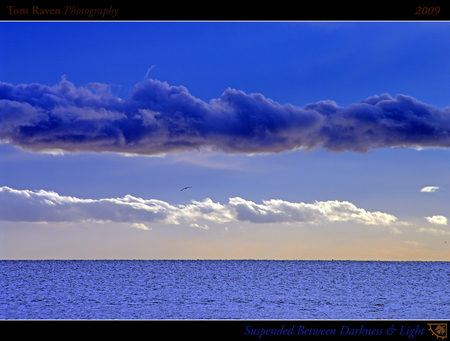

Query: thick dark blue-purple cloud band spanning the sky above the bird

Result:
[0,78,450,155]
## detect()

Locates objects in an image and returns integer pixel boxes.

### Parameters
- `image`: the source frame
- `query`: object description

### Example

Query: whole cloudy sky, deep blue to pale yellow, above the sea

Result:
[0,22,450,260]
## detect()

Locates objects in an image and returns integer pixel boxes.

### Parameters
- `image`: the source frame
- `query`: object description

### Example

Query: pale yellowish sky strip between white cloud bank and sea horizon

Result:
[0,218,450,261]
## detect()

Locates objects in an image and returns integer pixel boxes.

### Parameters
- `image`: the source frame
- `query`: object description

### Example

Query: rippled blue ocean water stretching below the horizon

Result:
[0,260,450,320]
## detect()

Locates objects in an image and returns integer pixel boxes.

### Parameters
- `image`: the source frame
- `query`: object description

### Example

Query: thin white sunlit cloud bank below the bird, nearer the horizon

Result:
[0,186,397,230]
